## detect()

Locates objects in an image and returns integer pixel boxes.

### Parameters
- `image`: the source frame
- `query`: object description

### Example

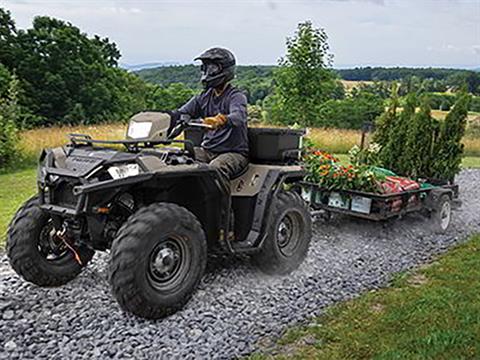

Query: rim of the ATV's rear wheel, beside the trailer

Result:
[277,211,303,257]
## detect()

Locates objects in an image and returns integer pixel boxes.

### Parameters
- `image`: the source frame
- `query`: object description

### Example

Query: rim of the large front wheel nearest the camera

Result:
[147,236,191,291]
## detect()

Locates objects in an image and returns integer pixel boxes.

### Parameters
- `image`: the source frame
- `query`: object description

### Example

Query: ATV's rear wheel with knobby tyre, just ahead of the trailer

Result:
[253,192,312,274]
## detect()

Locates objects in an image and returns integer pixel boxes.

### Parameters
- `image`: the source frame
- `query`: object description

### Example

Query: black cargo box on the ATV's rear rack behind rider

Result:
[185,128,305,163]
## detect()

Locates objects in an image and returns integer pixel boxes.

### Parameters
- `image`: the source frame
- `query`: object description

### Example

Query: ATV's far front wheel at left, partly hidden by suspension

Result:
[7,196,94,286]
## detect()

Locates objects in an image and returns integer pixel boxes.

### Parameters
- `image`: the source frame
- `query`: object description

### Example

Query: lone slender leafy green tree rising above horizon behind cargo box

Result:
[271,21,338,126]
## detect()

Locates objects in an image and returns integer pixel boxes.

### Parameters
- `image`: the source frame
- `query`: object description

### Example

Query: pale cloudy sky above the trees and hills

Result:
[0,0,480,67]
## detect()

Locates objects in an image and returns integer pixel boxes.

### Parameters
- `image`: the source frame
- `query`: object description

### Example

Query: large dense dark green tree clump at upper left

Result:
[0,9,146,127]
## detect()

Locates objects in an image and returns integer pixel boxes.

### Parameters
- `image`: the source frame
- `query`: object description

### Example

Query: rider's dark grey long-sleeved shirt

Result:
[178,84,248,156]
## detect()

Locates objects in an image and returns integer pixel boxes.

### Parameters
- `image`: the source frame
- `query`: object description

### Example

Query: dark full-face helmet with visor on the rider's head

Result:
[194,48,235,88]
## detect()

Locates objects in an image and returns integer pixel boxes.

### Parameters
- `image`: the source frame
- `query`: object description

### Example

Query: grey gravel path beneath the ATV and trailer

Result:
[0,170,480,359]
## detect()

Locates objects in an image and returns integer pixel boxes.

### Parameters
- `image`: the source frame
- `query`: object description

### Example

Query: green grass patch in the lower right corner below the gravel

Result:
[251,235,480,360]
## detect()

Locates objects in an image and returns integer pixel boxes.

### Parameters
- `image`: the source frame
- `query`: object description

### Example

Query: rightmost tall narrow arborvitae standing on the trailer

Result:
[432,92,470,182]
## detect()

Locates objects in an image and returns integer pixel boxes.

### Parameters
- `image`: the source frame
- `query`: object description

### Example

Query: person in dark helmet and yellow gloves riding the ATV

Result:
[176,48,248,192]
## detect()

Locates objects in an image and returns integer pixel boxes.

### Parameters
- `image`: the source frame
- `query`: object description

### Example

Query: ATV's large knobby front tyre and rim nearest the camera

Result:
[109,203,207,319]
